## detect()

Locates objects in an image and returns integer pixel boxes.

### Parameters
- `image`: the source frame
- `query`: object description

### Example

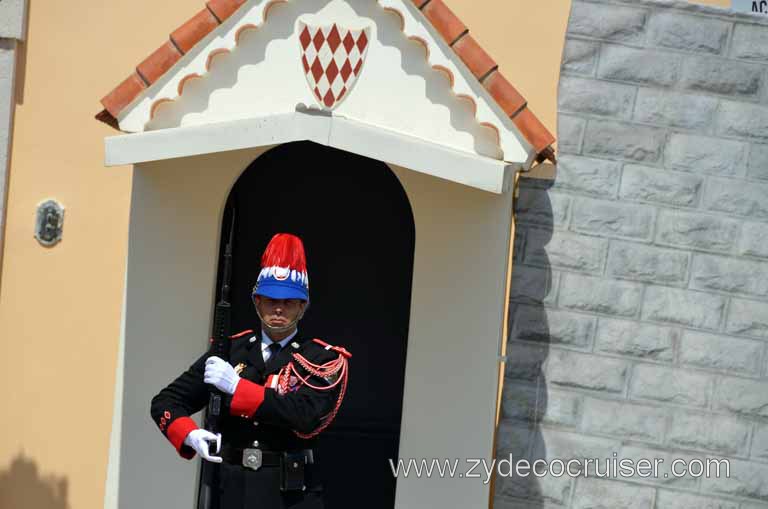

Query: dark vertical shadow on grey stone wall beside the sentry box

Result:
[493,178,556,509]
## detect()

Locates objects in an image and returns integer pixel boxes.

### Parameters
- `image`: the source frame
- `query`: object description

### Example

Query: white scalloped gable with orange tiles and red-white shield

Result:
[98,0,554,166]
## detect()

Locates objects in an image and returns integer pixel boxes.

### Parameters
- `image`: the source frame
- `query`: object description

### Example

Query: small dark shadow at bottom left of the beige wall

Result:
[0,452,70,509]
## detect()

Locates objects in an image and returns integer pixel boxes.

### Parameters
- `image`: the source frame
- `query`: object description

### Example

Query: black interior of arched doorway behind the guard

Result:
[210,142,415,509]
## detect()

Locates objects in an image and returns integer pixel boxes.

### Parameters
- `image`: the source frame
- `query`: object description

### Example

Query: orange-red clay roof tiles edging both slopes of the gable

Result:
[96,0,555,162]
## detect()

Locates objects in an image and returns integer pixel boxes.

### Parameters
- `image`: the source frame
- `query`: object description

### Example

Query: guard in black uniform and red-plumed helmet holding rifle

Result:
[151,233,351,509]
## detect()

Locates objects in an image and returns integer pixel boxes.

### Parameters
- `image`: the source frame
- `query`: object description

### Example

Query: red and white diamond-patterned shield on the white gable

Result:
[299,21,371,110]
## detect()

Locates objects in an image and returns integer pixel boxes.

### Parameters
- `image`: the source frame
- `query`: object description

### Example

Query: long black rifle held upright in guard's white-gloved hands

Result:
[198,203,236,509]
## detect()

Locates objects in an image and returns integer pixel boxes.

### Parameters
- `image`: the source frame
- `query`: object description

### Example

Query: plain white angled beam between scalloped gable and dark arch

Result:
[105,112,526,194]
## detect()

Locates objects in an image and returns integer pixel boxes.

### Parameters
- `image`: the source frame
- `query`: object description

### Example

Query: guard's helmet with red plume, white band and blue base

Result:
[251,233,309,302]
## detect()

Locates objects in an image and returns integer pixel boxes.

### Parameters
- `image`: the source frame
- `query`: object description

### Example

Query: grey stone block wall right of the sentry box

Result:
[494,0,768,509]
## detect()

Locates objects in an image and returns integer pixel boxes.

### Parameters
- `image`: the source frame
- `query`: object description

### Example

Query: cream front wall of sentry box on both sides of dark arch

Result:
[105,148,513,509]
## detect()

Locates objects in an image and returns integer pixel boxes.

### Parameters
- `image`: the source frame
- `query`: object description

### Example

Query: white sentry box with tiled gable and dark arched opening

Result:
[97,0,554,508]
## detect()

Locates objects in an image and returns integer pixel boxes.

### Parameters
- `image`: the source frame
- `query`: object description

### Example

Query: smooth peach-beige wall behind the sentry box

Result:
[0,0,729,509]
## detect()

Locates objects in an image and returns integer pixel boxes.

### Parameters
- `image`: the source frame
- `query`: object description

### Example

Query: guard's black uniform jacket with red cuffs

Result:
[151,330,341,459]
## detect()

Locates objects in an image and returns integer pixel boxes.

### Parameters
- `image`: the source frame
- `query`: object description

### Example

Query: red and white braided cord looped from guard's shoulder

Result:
[281,339,352,438]
